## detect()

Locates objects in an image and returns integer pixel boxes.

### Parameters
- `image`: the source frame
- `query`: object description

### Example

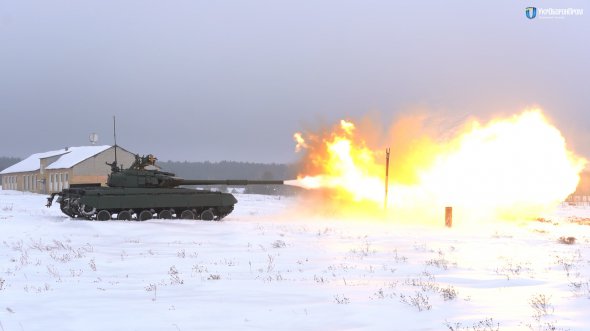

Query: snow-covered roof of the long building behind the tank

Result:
[0,145,112,175]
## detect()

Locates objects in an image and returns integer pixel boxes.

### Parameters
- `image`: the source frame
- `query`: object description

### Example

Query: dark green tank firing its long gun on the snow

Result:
[46,155,283,221]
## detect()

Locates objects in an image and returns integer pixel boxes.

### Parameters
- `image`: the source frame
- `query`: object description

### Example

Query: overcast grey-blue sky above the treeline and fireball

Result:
[0,0,590,162]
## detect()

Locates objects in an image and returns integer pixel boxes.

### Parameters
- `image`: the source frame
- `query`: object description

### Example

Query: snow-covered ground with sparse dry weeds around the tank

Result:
[0,191,590,331]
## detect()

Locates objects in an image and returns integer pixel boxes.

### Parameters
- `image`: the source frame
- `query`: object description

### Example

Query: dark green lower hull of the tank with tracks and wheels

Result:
[57,187,237,220]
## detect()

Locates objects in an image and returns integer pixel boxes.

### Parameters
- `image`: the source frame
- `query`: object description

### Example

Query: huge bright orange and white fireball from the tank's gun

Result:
[290,109,586,221]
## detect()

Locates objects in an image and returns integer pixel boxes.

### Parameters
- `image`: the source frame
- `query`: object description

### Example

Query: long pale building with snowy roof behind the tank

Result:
[0,145,135,194]
